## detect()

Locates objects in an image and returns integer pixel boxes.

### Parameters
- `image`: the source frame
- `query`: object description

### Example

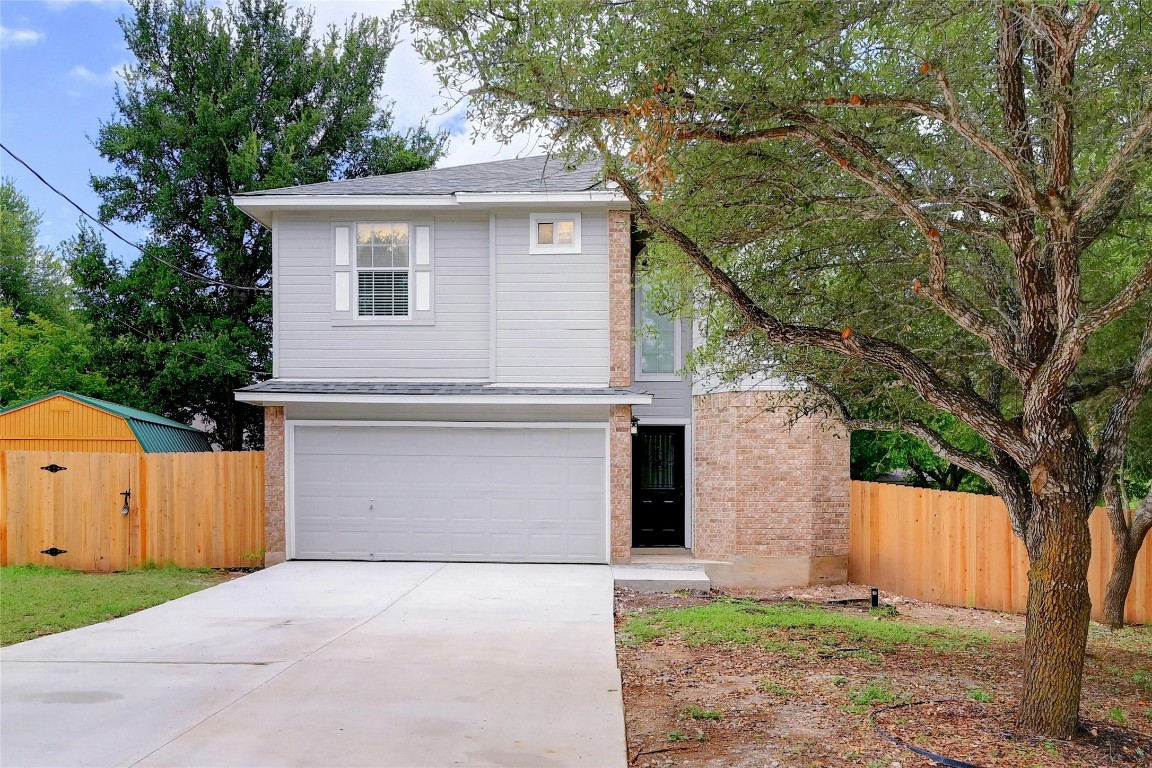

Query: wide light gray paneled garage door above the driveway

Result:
[293,425,607,563]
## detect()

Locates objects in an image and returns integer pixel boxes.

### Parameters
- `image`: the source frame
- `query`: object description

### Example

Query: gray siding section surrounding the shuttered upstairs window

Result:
[274,211,491,380]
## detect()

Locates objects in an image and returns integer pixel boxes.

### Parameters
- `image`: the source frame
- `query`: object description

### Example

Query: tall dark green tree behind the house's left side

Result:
[69,0,446,449]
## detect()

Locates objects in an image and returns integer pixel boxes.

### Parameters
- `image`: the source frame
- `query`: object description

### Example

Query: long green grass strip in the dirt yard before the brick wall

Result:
[621,600,988,661]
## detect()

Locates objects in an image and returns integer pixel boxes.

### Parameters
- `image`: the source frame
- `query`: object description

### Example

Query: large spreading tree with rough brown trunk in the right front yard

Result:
[410,0,1152,738]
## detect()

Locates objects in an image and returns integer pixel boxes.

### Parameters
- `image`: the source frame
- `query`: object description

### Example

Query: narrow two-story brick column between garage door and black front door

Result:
[608,211,632,563]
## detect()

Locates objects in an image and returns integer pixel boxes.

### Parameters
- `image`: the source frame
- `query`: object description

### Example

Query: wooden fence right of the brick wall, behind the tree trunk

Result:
[848,481,1152,624]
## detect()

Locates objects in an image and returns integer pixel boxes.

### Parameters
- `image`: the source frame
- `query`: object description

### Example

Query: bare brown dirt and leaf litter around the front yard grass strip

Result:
[616,585,1152,768]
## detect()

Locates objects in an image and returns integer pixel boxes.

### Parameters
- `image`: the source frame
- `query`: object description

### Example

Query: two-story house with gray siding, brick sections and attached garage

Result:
[235,157,849,585]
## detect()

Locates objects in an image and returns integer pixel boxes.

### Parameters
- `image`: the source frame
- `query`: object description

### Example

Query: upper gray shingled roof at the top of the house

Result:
[235,154,604,199]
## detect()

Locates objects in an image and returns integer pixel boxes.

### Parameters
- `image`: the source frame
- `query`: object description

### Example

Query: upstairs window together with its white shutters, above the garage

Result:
[333,221,432,322]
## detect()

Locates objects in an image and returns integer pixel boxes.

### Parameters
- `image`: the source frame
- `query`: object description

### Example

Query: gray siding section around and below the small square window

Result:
[495,211,608,386]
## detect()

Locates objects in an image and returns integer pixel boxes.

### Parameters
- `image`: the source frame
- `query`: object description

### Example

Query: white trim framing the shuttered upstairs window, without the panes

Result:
[329,219,435,327]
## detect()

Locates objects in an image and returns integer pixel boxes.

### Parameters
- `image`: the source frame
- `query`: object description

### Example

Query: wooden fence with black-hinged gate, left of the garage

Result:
[0,450,264,571]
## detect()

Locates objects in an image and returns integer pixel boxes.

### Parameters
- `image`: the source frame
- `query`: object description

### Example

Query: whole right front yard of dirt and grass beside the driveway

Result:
[616,591,1152,768]
